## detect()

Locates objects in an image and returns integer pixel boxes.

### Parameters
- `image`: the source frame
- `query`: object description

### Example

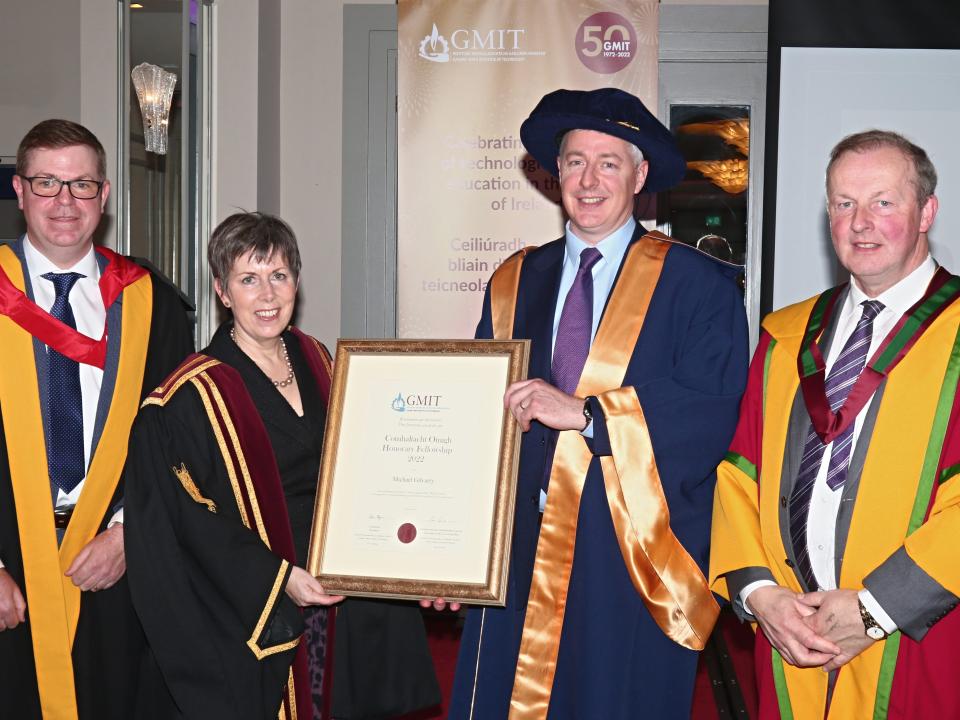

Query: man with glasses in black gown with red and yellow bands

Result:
[0,120,192,720]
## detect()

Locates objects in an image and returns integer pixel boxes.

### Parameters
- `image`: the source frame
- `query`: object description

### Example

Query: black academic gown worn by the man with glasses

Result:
[0,258,193,720]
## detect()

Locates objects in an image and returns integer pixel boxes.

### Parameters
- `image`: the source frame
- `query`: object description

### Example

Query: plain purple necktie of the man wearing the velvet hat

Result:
[551,247,603,395]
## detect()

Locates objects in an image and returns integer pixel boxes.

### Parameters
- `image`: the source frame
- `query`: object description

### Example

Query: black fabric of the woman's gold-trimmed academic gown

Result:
[126,326,439,720]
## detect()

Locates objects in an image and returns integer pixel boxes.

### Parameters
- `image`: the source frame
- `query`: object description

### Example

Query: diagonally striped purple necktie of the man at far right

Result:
[790,300,883,590]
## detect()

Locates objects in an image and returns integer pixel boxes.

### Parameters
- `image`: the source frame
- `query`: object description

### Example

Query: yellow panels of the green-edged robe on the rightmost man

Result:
[760,298,960,720]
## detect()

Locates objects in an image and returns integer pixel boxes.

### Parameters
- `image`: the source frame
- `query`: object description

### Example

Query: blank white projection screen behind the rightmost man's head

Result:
[773,48,960,308]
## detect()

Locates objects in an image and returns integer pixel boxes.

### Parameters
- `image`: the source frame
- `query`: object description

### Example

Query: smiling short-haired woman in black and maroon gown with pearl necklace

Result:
[125,213,439,720]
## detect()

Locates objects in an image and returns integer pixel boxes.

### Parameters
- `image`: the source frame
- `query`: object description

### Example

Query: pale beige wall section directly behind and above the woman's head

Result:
[208,0,393,346]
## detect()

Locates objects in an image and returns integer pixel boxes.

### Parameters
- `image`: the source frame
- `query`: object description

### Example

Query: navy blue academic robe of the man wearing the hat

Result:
[449,226,748,720]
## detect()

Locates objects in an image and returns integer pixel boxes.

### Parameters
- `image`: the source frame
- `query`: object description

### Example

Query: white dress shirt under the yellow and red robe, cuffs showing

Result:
[740,255,937,633]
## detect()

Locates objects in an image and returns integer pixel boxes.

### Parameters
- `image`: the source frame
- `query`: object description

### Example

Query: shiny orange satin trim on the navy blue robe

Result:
[491,233,719,720]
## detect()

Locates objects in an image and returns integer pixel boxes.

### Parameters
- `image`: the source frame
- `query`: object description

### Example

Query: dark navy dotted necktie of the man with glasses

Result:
[42,273,86,493]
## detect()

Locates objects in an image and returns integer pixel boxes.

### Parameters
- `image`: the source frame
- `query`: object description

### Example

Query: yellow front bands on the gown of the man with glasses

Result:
[0,246,153,720]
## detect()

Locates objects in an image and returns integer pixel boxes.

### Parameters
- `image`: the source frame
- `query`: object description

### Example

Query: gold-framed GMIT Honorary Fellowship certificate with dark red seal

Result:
[307,340,529,605]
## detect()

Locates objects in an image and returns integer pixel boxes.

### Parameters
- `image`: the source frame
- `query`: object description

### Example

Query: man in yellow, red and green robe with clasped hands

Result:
[710,131,960,720]
